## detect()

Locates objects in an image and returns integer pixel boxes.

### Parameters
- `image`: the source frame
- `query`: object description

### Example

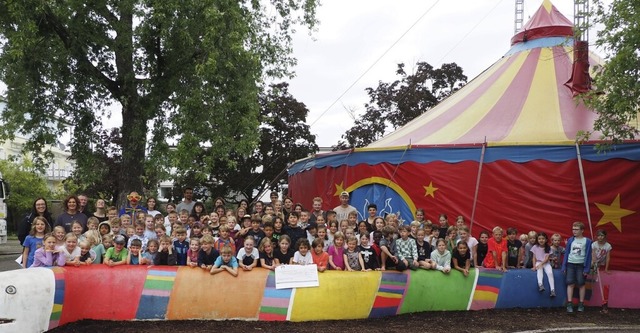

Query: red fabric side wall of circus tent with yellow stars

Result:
[289,148,640,271]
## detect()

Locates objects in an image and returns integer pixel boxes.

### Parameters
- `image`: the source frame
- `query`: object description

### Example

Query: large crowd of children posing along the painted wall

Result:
[23,198,611,311]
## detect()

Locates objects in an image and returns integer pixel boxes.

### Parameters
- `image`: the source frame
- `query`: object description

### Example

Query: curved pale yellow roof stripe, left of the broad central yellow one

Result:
[422,51,531,144]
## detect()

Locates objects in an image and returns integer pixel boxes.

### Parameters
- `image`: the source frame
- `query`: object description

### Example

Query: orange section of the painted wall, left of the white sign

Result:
[166,267,269,320]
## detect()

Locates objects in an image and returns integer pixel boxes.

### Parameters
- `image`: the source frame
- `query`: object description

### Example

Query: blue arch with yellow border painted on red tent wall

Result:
[346,177,416,224]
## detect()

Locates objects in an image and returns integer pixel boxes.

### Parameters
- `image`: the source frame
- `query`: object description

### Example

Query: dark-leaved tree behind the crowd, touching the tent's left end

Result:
[174,83,318,201]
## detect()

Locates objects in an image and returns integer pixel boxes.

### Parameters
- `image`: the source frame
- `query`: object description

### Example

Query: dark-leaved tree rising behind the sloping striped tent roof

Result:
[334,62,467,150]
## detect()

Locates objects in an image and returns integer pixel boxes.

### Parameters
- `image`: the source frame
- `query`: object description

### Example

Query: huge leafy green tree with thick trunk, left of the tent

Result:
[0,0,317,205]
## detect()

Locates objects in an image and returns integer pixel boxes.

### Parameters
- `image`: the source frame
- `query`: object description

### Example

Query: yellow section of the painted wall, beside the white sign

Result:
[291,271,382,321]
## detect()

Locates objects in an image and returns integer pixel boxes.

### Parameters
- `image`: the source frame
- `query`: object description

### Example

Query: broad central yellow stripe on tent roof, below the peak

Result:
[503,48,569,142]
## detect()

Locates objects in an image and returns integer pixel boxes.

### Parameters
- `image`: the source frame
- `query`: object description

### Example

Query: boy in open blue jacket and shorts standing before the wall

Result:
[562,222,592,313]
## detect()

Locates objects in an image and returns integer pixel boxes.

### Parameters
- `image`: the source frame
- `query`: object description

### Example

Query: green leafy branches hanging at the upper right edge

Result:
[584,0,640,143]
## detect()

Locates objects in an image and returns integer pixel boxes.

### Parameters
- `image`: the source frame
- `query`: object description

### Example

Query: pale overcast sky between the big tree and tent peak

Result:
[0,0,595,147]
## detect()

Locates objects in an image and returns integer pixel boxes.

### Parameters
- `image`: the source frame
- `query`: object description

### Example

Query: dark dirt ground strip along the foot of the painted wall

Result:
[51,308,640,333]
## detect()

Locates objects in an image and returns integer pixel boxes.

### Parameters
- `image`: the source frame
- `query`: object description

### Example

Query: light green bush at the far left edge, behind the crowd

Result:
[0,159,51,223]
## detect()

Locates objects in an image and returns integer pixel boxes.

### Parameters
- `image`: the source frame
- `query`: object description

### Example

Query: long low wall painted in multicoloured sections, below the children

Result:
[0,265,640,332]
